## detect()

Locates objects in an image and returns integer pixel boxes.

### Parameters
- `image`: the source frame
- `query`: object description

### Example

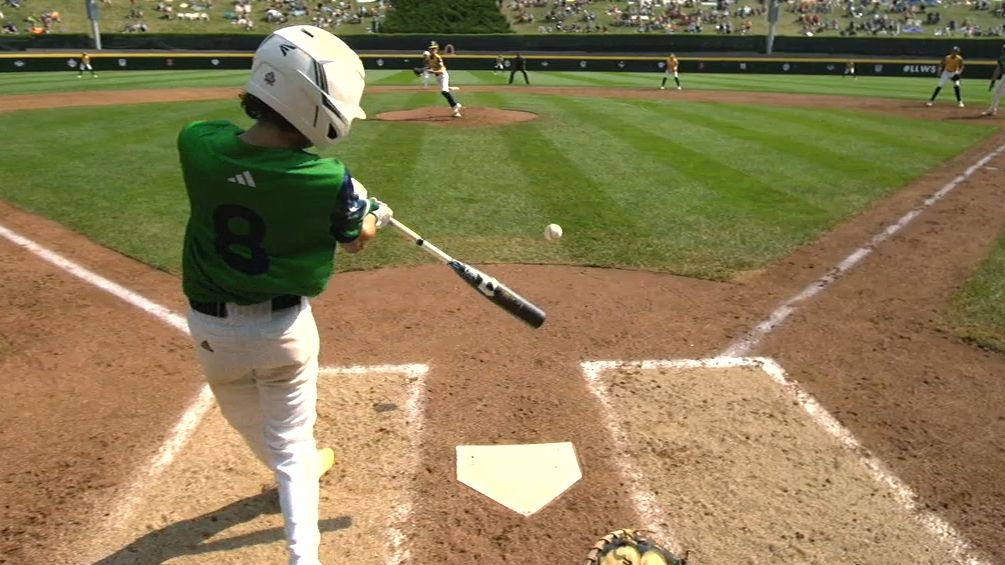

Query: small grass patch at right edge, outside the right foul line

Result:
[952,233,1005,353]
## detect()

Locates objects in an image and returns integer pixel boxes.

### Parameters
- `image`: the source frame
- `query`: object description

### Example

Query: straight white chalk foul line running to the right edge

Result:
[723,145,1005,357]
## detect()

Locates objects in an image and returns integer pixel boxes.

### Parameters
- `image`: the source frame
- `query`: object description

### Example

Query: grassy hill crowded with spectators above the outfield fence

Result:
[0,0,1005,38]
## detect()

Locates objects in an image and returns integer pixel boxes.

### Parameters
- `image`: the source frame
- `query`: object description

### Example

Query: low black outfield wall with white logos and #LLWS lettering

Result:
[0,51,994,76]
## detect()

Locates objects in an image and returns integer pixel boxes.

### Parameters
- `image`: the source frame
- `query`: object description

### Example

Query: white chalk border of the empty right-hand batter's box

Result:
[580,356,990,565]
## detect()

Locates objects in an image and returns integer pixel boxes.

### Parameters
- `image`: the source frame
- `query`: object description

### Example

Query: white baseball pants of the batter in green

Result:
[188,299,321,565]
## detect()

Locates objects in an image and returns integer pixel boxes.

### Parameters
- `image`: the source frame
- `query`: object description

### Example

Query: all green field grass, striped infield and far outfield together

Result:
[0,71,1005,343]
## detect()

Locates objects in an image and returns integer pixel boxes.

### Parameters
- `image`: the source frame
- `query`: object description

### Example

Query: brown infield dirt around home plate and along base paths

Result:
[0,86,1005,565]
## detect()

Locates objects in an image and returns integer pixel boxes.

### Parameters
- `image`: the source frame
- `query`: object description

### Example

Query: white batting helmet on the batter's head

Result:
[244,25,367,147]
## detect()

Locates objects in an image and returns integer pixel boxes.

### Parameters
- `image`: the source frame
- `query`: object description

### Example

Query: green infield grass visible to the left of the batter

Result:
[0,102,221,270]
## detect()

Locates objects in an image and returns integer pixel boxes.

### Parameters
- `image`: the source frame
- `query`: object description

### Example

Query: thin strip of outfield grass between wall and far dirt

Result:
[0,68,991,108]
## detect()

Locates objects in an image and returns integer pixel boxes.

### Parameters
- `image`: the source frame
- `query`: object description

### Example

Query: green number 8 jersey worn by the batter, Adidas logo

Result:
[178,121,367,305]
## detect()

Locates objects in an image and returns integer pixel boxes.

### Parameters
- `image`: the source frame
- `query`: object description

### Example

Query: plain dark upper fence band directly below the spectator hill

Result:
[0,33,1002,59]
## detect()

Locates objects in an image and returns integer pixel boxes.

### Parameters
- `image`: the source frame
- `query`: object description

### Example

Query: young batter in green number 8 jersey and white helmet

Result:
[178,25,393,565]
